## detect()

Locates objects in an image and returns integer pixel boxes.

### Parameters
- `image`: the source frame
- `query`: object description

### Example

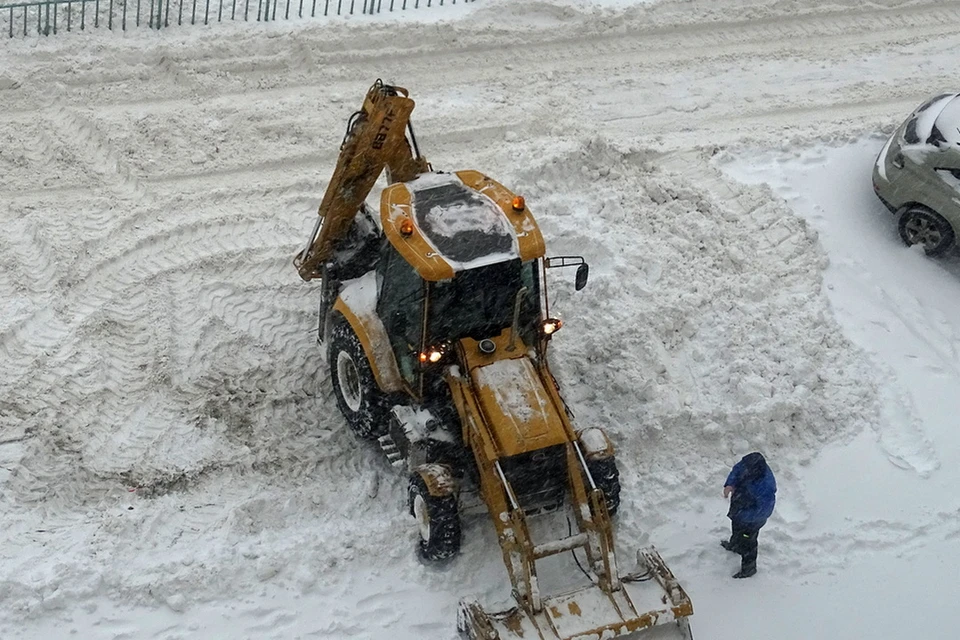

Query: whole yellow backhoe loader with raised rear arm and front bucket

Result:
[294,80,693,640]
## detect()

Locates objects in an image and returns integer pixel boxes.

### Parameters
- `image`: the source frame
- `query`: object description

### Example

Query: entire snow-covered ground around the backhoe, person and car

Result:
[0,0,960,640]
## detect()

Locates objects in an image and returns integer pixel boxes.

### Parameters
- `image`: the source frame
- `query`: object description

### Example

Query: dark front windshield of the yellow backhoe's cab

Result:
[427,259,539,344]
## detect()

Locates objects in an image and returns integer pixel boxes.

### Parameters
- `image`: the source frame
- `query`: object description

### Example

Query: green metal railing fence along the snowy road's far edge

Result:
[0,0,474,38]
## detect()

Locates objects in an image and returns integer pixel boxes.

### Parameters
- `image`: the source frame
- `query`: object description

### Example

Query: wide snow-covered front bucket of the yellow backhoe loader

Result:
[457,547,693,640]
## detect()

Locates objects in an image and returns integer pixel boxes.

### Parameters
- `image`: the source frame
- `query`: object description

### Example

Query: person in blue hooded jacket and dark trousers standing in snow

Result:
[720,452,777,578]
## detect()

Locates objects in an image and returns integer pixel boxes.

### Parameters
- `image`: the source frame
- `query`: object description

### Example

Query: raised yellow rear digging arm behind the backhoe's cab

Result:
[293,80,429,280]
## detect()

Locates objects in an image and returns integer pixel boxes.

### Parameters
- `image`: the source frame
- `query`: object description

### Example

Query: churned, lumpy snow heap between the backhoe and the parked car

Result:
[502,140,877,512]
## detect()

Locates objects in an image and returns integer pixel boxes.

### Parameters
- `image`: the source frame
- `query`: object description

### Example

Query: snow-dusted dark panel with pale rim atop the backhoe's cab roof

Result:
[407,173,519,271]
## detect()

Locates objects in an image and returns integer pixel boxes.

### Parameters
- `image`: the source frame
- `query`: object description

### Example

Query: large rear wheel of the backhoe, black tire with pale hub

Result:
[329,317,390,440]
